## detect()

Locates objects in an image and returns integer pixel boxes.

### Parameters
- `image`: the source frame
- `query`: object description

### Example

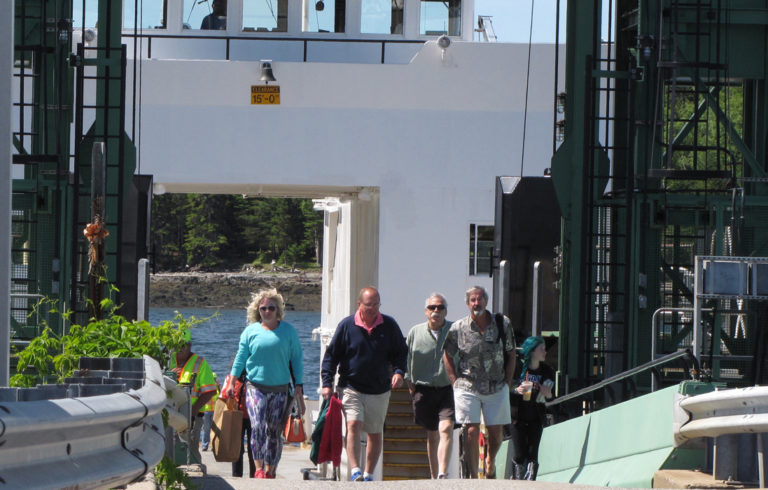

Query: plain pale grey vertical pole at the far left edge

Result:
[0,2,15,386]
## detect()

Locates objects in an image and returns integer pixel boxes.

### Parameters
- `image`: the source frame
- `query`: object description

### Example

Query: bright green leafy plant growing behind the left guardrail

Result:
[10,299,205,387]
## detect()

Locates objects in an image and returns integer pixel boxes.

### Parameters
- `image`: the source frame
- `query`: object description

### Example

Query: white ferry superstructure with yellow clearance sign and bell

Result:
[99,0,555,340]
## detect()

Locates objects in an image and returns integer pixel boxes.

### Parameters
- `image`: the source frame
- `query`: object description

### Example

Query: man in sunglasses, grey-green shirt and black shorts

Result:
[405,293,454,479]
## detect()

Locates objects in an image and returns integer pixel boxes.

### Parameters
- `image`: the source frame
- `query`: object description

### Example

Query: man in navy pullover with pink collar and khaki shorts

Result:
[322,287,408,481]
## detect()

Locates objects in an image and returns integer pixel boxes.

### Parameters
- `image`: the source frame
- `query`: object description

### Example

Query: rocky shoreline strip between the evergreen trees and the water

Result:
[149,271,322,311]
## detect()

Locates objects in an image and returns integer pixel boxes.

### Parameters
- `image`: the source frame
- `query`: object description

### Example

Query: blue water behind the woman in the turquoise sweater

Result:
[149,308,320,399]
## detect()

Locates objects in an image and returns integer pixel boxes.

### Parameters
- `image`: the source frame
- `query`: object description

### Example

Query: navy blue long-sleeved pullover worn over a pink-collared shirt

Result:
[322,315,408,395]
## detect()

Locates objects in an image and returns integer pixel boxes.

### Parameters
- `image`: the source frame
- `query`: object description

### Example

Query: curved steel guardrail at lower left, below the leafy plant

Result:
[0,356,167,490]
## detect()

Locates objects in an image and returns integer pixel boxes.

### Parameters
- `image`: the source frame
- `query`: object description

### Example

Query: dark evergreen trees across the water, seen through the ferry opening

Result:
[152,194,323,270]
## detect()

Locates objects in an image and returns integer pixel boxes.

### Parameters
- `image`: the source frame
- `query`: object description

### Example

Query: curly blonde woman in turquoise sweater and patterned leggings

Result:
[230,289,304,478]
